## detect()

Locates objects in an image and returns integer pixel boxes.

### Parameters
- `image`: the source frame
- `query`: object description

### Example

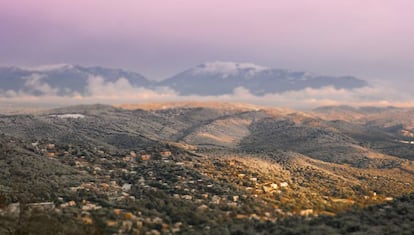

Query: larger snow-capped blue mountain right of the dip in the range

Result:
[161,62,368,96]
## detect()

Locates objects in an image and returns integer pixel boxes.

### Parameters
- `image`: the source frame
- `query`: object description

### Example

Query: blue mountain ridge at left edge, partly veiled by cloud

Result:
[0,64,151,96]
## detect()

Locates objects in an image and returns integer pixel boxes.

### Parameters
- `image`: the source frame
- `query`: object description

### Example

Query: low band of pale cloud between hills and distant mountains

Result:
[0,77,414,109]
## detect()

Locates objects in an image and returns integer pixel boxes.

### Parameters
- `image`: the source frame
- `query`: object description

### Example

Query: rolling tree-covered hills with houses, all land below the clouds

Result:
[0,103,414,234]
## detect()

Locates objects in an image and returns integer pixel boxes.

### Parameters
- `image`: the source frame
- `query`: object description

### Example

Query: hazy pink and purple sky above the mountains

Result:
[0,0,414,87]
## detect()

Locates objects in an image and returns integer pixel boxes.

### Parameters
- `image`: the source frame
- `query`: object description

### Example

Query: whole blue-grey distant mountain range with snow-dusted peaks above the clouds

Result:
[0,61,368,96]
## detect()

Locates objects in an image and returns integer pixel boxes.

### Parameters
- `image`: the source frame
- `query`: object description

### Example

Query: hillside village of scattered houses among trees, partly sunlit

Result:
[0,138,392,234]
